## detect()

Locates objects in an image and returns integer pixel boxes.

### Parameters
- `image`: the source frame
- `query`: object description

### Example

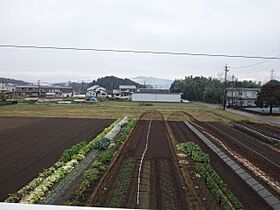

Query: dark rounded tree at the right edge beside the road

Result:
[257,80,280,114]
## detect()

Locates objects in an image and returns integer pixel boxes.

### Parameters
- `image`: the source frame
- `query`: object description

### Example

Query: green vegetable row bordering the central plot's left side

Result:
[64,120,136,206]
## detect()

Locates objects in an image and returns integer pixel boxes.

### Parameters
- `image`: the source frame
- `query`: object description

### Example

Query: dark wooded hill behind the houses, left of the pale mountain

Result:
[88,76,140,90]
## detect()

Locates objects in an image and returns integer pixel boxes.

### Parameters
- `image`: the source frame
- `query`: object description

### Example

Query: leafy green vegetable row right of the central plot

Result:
[177,141,244,209]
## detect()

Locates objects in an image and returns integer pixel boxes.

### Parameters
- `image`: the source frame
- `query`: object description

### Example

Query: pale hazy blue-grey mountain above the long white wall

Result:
[131,76,173,89]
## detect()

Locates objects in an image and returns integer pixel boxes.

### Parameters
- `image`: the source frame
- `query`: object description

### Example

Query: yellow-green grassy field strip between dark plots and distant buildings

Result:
[0,101,258,122]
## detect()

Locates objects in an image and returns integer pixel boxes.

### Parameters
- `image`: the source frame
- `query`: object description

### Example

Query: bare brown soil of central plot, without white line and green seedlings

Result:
[91,120,188,209]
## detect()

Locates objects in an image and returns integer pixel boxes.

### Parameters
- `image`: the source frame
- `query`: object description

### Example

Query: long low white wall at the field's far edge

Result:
[131,93,181,102]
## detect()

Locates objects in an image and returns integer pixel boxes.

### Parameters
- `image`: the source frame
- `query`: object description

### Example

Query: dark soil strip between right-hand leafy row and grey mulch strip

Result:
[169,122,270,209]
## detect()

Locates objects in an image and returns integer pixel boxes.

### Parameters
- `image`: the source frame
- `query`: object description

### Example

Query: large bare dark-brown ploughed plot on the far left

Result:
[0,117,112,201]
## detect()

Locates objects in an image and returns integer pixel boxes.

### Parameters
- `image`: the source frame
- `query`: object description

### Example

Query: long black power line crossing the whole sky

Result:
[0,44,280,60]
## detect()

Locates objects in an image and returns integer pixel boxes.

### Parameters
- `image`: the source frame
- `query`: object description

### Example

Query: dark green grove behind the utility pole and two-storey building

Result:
[170,76,260,103]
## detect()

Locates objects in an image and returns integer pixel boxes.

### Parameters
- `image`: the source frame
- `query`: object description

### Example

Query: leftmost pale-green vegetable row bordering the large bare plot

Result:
[5,120,119,203]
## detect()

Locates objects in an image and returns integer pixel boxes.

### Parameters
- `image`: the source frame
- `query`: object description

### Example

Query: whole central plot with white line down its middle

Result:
[89,114,188,209]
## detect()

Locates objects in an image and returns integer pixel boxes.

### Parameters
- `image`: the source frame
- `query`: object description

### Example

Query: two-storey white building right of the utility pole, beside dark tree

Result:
[226,88,260,107]
